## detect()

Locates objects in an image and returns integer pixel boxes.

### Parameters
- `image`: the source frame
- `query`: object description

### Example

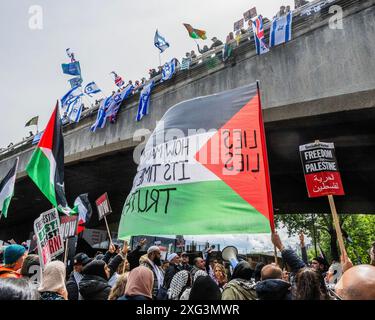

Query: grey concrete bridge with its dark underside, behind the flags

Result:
[0,0,375,239]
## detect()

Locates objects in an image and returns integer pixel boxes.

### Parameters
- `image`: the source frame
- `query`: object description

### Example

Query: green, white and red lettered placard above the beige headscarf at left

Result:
[34,208,64,269]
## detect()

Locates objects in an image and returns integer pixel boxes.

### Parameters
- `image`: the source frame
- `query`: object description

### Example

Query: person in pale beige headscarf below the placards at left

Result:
[38,261,68,300]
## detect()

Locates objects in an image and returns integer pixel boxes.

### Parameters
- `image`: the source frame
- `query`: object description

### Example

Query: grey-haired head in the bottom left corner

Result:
[0,278,40,301]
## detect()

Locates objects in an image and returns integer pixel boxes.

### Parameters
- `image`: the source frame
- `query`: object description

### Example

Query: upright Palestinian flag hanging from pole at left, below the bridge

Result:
[26,102,71,214]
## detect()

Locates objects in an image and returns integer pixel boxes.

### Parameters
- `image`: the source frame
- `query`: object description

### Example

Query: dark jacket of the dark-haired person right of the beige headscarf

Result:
[79,275,111,300]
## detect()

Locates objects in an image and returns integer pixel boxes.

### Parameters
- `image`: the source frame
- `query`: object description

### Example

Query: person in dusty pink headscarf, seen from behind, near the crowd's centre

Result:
[118,266,154,300]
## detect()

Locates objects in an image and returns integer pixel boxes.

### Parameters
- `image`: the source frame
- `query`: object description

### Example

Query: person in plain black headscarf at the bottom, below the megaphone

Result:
[189,275,221,300]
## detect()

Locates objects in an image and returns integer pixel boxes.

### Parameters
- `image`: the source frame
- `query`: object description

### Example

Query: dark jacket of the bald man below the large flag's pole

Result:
[255,279,292,300]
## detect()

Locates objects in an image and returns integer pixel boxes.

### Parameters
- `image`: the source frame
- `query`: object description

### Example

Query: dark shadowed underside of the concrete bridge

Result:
[0,108,375,241]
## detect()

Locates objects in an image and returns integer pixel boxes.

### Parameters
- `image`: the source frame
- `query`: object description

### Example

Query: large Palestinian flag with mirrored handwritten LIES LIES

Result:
[119,84,274,238]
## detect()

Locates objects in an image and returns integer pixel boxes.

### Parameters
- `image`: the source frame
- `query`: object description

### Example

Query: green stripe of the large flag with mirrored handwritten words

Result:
[119,180,270,238]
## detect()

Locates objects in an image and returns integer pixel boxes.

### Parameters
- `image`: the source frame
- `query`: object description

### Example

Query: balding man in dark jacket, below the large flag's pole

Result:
[255,264,292,300]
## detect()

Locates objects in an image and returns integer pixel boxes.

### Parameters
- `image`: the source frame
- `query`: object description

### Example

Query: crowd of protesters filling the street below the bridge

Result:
[0,233,375,300]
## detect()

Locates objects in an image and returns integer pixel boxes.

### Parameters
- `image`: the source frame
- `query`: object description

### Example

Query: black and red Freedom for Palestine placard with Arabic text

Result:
[299,142,345,198]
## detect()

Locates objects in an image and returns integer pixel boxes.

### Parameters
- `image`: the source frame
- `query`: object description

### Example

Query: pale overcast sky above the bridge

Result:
[0,0,294,147]
